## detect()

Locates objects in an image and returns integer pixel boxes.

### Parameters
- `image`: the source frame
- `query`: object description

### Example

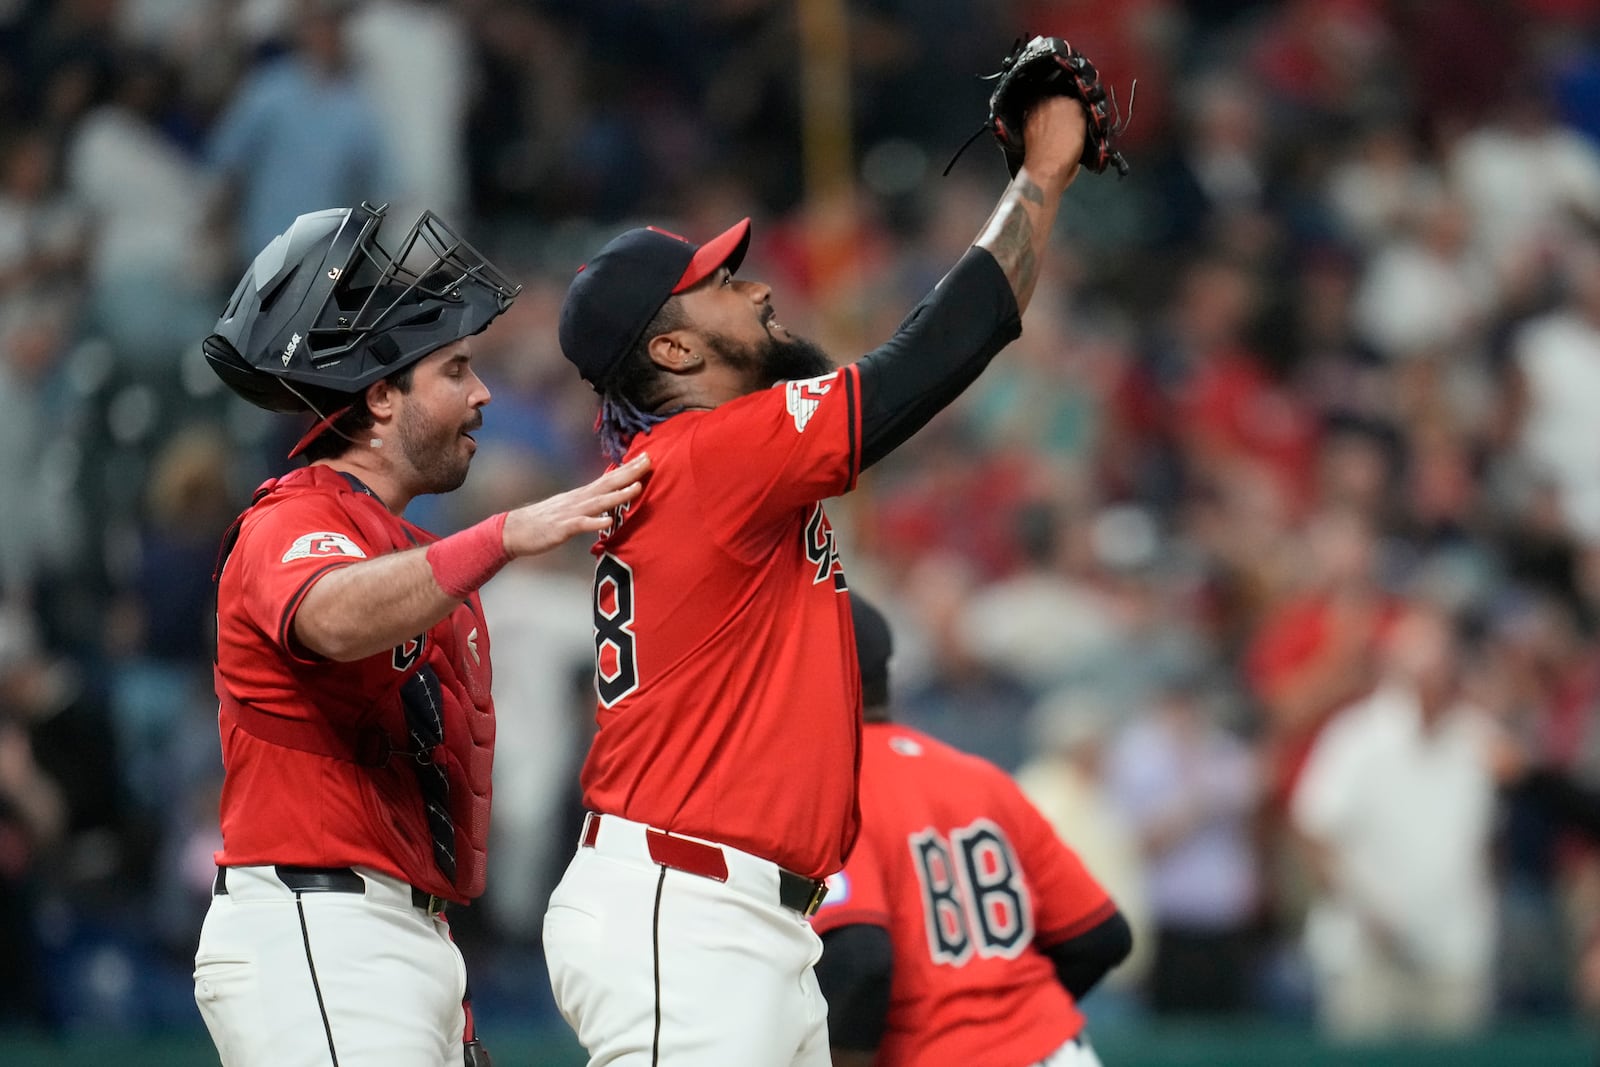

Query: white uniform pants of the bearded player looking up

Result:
[544,816,830,1067]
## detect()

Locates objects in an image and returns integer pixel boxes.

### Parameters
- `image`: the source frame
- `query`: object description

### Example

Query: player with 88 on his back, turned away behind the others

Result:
[811,593,1133,1067]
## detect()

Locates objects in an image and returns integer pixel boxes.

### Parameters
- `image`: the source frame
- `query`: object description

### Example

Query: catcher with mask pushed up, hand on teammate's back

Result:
[195,206,648,1067]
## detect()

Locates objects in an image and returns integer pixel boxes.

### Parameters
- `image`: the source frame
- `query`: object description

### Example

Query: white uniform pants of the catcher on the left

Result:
[195,867,467,1067]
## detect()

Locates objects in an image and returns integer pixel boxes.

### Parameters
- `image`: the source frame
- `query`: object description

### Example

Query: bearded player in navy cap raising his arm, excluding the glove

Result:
[544,47,1107,1067]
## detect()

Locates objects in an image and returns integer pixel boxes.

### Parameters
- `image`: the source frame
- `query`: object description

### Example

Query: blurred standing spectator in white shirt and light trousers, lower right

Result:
[1291,603,1494,1040]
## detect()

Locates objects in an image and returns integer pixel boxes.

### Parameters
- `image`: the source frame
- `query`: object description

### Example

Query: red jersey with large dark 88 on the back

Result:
[811,723,1115,1067]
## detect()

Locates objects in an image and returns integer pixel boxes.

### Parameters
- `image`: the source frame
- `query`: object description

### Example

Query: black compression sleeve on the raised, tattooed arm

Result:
[858,246,1022,470]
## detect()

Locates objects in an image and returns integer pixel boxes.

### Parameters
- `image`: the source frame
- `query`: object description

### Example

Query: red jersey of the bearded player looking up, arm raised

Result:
[582,366,861,878]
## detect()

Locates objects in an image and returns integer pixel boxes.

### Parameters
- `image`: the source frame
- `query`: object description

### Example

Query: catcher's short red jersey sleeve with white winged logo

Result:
[222,493,384,662]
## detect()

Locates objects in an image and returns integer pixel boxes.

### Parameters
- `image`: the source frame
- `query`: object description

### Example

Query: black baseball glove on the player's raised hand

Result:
[946,37,1138,178]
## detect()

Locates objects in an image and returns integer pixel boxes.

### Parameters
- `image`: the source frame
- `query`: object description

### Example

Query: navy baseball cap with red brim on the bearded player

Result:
[558,219,750,390]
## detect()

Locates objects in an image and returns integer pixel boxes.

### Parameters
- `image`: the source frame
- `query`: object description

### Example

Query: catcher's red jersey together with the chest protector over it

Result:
[216,466,494,901]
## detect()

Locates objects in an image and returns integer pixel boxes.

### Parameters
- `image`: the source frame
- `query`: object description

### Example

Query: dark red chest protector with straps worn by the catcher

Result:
[213,466,494,901]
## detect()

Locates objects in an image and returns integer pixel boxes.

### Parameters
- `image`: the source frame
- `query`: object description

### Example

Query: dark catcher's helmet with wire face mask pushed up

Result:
[203,203,522,414]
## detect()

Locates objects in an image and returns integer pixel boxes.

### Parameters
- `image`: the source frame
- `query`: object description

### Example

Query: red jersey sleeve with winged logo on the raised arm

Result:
[690,366,861,550]
